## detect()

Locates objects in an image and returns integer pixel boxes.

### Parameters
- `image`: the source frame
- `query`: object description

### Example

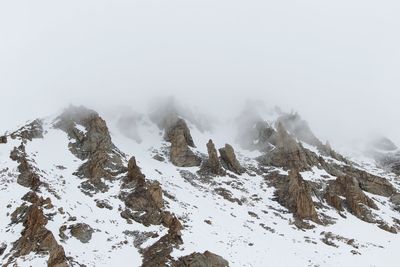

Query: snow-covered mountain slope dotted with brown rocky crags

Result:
[0,106,400,267]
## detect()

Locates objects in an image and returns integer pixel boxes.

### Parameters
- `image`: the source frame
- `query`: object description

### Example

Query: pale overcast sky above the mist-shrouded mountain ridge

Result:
[0,0,400,147]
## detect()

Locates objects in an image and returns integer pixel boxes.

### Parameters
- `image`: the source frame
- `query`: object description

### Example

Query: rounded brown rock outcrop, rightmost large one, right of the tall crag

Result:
[325,175,378,222]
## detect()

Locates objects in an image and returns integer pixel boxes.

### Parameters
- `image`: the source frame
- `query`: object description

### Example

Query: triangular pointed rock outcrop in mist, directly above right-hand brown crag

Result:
[258,123,319,171]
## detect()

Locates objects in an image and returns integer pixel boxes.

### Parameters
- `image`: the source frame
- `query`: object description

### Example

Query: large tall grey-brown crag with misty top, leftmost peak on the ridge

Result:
[54,107,126,193]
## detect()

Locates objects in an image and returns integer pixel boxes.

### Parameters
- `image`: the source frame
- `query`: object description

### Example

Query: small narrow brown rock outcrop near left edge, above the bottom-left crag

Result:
[10,143,41,190]
